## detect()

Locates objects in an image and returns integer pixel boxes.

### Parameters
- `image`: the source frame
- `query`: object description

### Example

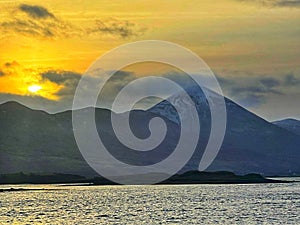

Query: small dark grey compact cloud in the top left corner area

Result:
[19,4,55,19]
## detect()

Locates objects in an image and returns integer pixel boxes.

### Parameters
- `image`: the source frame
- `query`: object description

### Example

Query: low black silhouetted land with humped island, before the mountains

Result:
[0,171,287,185]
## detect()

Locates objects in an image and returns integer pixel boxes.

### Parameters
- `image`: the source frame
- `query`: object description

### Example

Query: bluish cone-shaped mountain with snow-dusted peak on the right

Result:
[150,86,300,175]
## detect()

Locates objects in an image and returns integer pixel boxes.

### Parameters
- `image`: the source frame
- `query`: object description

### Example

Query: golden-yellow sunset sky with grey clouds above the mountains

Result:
[0,0,300,121]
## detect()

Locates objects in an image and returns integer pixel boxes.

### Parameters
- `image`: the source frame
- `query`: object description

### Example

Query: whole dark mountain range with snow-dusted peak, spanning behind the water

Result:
[0,87,300,176]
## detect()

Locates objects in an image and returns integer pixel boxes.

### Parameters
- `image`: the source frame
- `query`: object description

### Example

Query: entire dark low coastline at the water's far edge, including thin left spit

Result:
[0,171,300,188]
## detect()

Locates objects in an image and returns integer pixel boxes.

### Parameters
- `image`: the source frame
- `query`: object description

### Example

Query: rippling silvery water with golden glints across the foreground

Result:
[0,180,300,224]
